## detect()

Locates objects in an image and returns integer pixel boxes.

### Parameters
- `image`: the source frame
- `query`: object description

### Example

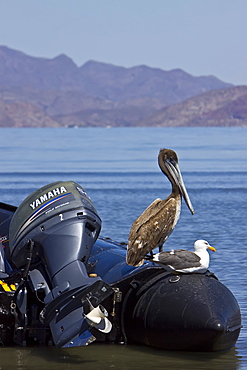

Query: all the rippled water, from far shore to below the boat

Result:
[0,128,247,370]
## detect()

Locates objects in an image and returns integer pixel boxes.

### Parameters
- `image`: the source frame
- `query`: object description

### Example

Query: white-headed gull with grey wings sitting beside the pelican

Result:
[146,240,216,273]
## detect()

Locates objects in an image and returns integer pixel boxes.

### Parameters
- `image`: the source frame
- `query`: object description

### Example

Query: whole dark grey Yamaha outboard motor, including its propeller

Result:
[8,181,112,347]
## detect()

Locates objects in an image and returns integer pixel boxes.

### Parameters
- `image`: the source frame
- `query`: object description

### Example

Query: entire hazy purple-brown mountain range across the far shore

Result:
[0,46,247,127]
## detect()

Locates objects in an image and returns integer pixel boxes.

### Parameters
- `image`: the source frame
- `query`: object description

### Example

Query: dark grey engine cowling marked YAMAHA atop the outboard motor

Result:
[9,181,101,278]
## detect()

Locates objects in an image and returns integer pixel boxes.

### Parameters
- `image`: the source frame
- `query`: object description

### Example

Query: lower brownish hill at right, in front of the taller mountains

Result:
[138,86,247,127]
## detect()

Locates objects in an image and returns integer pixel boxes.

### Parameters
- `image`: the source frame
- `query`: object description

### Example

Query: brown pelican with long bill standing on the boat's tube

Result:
[126,149,194,266]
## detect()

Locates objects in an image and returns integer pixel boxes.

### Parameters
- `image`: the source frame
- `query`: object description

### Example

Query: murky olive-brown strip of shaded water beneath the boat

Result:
[0,343,241,370]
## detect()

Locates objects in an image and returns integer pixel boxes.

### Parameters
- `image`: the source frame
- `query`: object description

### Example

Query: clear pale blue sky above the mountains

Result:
[0,0,247,85]
